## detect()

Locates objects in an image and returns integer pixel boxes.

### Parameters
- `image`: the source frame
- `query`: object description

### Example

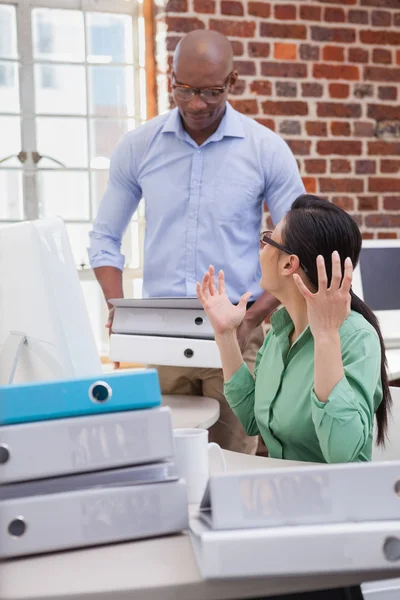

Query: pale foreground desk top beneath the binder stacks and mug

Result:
[0,451,400,600]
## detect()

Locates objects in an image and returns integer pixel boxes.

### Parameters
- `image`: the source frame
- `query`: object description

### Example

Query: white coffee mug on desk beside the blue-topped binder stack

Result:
[174,429,226,504]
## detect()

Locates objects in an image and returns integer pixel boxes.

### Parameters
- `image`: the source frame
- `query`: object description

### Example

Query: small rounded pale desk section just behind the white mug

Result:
[163,395,219,429]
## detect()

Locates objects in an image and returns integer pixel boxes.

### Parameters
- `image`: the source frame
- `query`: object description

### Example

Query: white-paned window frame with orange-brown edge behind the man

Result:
[0,0,157,354]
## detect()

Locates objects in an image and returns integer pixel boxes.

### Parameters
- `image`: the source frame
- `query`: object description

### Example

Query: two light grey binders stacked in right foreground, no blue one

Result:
[190,461,400,580]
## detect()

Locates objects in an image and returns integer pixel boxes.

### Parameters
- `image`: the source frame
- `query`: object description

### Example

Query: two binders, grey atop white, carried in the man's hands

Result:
[110,298,221,368]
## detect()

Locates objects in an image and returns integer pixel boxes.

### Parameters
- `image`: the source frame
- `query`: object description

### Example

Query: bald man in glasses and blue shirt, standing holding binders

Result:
[89,30,304,454]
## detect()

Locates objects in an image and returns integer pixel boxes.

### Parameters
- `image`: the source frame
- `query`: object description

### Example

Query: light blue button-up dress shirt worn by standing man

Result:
[89,103,304,302]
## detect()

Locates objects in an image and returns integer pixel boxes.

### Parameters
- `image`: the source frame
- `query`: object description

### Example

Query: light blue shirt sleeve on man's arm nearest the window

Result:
[88,134,142,271]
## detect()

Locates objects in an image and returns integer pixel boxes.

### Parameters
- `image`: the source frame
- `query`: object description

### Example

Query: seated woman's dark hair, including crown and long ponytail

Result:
[283,194,392,446]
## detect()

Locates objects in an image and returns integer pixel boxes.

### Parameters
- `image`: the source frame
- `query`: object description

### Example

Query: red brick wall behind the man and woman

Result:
[156,0,400,237]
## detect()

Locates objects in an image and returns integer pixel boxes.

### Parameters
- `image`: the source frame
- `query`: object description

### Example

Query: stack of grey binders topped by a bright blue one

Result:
[0,369,188,558]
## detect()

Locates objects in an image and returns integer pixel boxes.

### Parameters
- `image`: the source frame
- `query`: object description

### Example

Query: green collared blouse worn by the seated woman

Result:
[224,308,382,463]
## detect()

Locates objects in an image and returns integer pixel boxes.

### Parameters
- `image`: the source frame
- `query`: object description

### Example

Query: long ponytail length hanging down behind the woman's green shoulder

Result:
[350,291,392,446]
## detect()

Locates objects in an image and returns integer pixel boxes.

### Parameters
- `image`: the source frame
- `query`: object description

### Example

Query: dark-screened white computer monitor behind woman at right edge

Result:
[353,240,400,348]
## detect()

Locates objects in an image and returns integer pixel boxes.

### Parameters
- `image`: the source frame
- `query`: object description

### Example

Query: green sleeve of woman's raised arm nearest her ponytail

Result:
[311,329,382,463]
